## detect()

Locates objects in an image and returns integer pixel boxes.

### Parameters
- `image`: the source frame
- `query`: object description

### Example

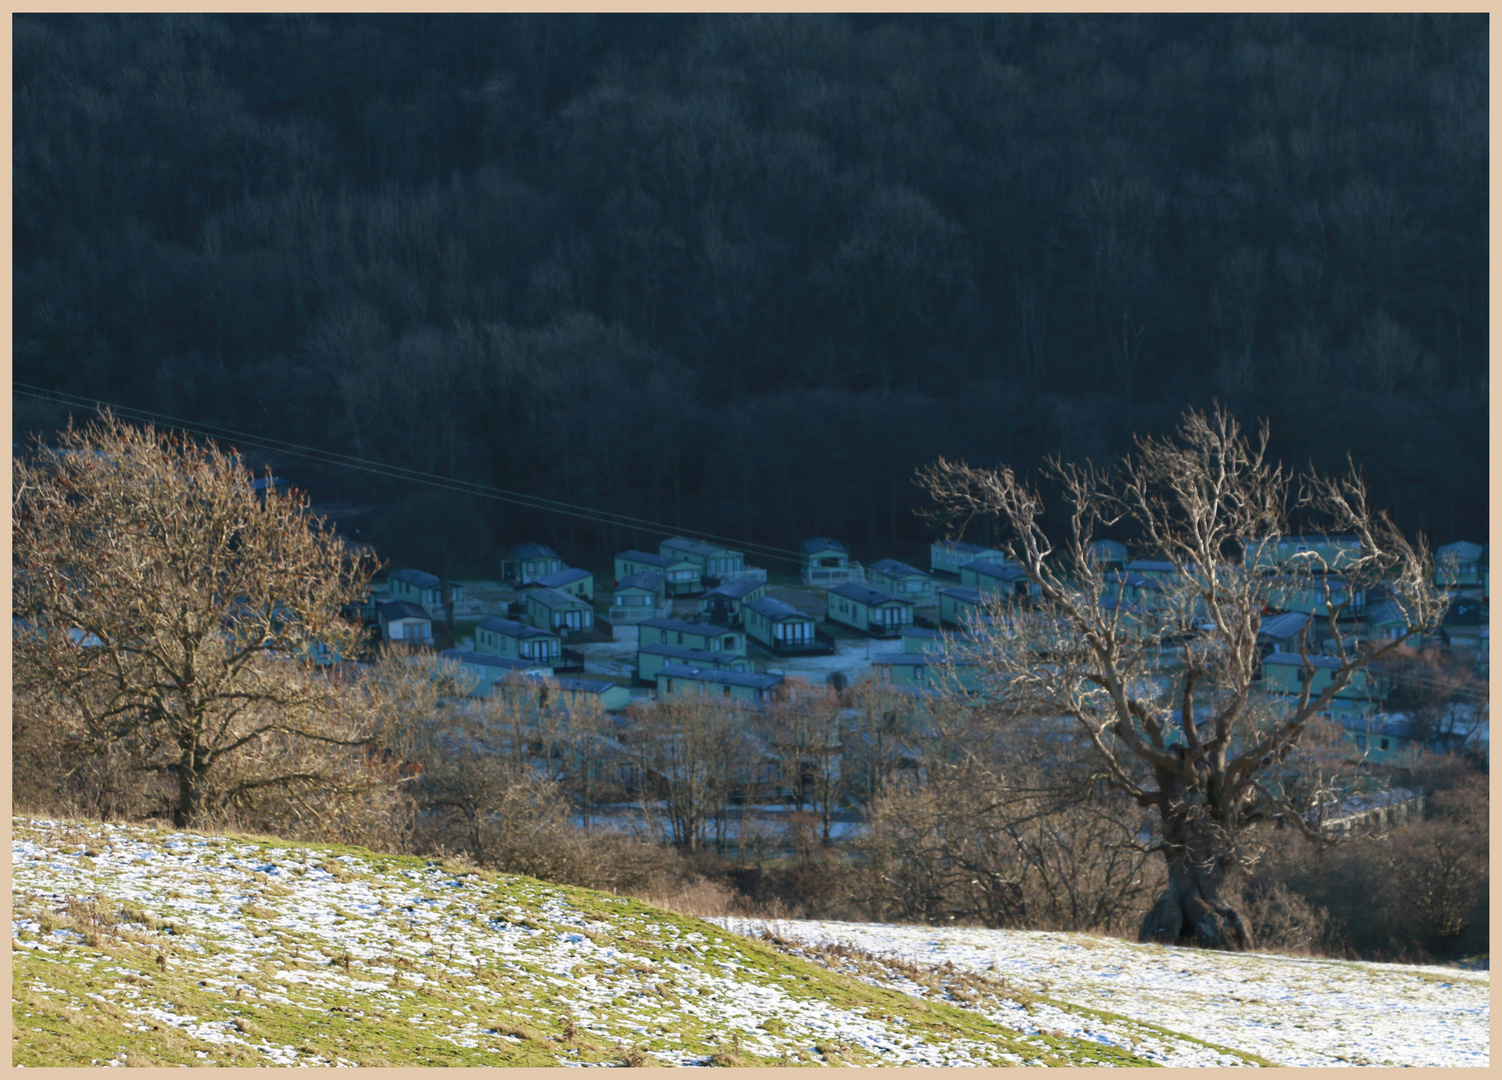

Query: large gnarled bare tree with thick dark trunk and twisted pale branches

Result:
[919,409,1442,948]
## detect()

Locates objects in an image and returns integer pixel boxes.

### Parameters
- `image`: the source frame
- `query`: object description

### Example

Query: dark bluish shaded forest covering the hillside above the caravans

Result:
[12,15,1488,569]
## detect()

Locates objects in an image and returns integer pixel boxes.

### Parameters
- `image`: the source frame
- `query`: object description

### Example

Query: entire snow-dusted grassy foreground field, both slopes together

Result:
[12,819,1490,1066]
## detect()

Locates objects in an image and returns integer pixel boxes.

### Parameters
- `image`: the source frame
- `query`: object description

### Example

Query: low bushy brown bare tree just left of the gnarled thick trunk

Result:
[858,691,1161,931]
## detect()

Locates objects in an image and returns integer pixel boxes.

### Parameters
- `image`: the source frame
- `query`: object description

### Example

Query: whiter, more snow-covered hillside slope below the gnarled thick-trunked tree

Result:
[712,918,1491,1068]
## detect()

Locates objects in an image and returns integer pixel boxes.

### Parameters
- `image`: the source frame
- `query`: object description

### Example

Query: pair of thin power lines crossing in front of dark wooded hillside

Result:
[11,382,802,563]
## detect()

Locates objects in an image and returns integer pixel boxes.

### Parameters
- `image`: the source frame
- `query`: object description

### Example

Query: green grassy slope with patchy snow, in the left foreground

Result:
[12,819,1171,1065]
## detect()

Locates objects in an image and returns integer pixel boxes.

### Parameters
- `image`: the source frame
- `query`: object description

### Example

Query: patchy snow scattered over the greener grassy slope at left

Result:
[12,819,1141,1065]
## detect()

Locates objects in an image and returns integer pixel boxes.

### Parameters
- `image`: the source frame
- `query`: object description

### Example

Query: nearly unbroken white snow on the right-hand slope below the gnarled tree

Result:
[712,918,1491,1066]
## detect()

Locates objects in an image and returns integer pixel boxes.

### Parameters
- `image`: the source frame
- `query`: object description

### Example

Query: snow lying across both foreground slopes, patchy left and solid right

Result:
[23,819,1490,1066]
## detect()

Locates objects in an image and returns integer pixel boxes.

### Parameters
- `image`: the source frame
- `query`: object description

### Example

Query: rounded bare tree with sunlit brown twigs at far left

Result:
[12,413,374,826]
